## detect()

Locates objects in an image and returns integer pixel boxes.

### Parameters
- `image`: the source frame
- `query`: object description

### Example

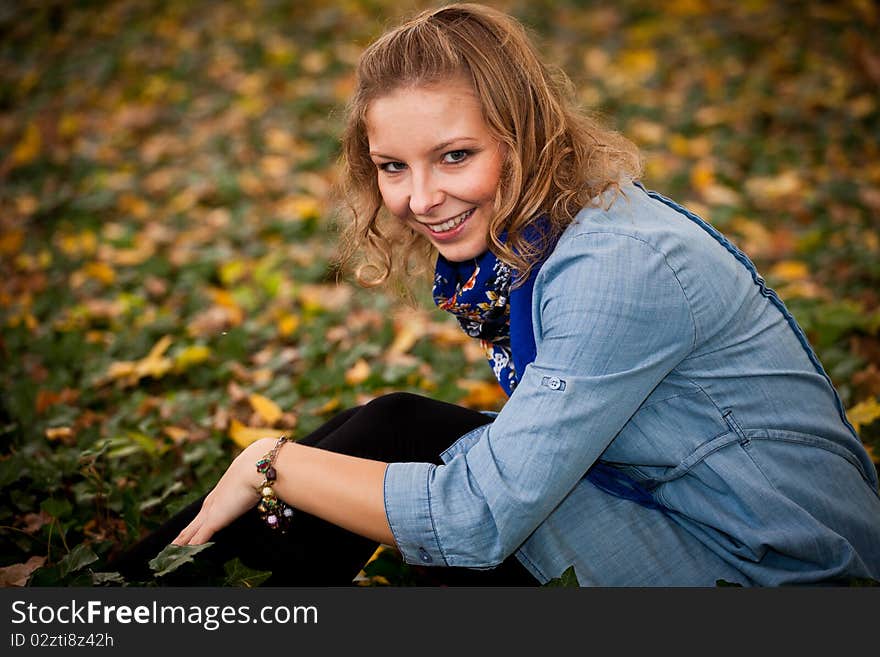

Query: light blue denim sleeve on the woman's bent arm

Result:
[385,231,696,568]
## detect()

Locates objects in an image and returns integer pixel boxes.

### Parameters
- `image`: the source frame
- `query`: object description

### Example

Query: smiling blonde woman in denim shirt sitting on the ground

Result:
[117,4,880,586]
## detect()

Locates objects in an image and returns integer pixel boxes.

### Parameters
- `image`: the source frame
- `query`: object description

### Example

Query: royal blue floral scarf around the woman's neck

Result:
[433,219,663,510]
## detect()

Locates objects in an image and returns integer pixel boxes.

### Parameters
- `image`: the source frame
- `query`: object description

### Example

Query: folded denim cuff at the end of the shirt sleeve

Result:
[384,463,448,566]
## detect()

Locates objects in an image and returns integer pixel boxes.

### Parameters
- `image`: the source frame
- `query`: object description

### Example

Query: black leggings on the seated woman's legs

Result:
[111,393,538,586]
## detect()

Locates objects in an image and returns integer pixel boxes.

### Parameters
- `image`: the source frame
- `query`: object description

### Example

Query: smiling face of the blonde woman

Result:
[366,79,504,262]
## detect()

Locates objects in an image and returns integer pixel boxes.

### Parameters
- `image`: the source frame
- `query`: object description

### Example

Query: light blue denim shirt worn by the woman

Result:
[385,185,880,585]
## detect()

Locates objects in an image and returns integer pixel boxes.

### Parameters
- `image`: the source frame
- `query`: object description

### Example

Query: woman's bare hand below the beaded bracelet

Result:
[172,438,275,545]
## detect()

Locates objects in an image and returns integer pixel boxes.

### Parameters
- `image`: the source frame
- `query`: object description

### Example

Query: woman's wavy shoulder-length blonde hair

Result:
[339,3,641,289]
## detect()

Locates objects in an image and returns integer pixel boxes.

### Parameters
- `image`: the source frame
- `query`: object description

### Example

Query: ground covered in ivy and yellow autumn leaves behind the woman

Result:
[0,0,880,586]
